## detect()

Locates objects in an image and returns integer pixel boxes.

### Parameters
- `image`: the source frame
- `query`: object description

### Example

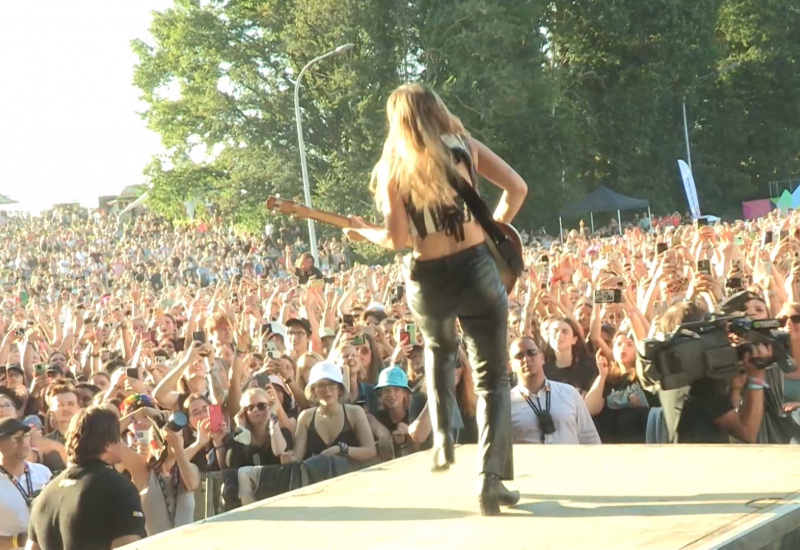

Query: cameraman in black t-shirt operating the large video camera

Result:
[658,302,772,443]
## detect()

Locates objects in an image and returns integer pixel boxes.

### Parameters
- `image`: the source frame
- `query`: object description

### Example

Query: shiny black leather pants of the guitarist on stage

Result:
[406,244,514,479]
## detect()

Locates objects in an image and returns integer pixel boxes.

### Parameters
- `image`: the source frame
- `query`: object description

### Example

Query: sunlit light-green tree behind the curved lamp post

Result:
[133,0,412,235]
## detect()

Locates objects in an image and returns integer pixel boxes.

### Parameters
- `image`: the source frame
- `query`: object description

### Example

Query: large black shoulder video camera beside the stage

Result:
[636,292,794,392]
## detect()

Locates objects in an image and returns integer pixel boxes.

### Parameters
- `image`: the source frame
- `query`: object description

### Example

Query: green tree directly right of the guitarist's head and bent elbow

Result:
[417,0,582,227]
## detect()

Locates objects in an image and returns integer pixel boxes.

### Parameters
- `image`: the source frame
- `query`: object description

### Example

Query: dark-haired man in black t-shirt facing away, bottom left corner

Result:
[26,407,147,550]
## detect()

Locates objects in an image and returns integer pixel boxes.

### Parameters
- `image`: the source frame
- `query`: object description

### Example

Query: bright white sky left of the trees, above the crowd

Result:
[0,0,172,210]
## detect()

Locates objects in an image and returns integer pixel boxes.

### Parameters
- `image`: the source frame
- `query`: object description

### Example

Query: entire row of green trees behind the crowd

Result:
[132,0,800,231]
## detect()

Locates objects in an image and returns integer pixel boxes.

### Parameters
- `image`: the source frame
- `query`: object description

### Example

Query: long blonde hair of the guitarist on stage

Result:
[370,83,467,208]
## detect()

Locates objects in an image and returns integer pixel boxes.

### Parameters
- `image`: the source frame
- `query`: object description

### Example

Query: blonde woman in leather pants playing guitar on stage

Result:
[344,84,527,515]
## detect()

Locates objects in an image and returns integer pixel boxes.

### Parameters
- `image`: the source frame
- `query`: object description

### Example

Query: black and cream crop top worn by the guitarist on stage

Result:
[405,134,474,241]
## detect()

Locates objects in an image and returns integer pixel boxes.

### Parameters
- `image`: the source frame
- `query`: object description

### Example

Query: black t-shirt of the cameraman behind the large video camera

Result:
[678,378,733,443]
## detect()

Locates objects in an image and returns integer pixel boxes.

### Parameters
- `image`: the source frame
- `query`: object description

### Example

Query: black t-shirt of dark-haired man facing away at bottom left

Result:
[28,460,147,550]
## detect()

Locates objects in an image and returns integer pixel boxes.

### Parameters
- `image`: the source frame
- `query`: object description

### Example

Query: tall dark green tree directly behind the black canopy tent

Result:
[547,0,720,216]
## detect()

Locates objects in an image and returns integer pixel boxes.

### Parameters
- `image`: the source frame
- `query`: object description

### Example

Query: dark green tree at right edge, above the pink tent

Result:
[692,0,800,211]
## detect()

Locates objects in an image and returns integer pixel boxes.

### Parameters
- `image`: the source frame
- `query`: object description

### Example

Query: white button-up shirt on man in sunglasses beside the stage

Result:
[511,380,600,444]
